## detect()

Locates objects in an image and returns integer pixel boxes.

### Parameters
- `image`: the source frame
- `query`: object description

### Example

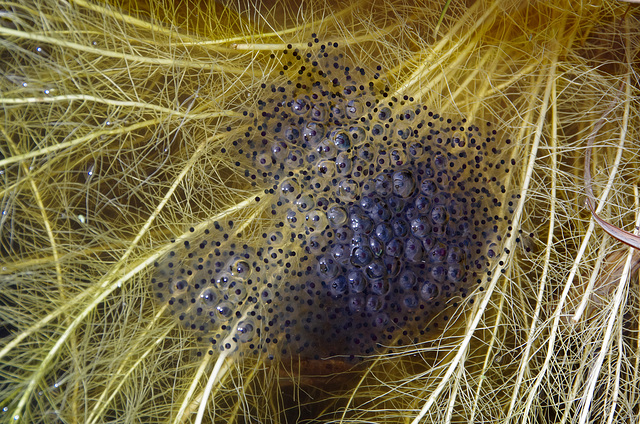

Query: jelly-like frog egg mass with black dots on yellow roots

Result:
[152,39,515,359]
